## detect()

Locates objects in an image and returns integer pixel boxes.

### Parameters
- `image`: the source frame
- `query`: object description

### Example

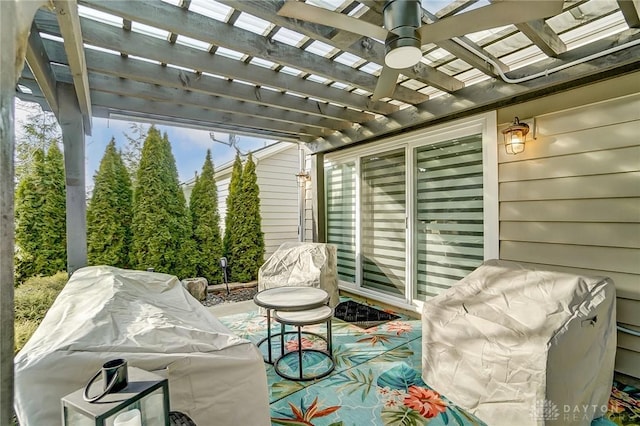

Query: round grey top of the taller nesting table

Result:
[253,286,329,311]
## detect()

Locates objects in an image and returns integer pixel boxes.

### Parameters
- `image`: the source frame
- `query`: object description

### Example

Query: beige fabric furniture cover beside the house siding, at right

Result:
[422,260,616,426]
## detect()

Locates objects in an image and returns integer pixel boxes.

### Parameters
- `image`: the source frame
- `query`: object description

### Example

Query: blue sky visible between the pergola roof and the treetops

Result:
[15,103,275,189]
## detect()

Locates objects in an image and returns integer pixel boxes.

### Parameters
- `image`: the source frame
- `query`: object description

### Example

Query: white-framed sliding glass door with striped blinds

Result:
[325,114,498,307]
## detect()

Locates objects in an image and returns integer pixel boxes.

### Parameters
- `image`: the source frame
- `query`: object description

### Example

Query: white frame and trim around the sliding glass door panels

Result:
[325,111,499,312]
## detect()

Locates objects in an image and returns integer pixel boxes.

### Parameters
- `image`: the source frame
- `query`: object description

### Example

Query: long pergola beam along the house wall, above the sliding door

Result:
[309,30,640,153]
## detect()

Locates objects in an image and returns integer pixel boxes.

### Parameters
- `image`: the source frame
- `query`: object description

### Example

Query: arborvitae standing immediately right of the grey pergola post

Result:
[87,138,133,268]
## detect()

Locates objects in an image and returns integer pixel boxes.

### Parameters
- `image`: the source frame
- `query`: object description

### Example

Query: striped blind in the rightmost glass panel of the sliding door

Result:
[414,135,484,300]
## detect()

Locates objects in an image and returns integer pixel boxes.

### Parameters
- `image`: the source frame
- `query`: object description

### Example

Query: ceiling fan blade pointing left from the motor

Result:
[278,1,389,42]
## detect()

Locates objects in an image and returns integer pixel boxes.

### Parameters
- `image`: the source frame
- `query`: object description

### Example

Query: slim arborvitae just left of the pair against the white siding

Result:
[189,150,222,283]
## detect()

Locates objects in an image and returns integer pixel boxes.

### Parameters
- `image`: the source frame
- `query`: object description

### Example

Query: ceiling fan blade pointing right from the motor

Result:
[418,0,564,44]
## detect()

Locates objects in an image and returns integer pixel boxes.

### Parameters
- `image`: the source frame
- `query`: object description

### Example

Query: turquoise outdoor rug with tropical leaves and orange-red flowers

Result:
[220,298,640,426]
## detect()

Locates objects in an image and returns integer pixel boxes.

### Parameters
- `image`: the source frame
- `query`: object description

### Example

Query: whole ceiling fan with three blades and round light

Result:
[278,0,563,101]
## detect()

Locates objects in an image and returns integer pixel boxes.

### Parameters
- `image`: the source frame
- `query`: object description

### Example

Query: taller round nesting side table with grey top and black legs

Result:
[253,286,329,364]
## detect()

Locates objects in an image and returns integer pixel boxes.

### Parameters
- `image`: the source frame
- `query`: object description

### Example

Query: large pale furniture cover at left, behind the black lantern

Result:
[15,266,271,426]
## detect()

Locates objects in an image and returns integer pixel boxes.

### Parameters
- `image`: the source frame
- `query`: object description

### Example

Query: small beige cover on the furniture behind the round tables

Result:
[258,243,340,308]
